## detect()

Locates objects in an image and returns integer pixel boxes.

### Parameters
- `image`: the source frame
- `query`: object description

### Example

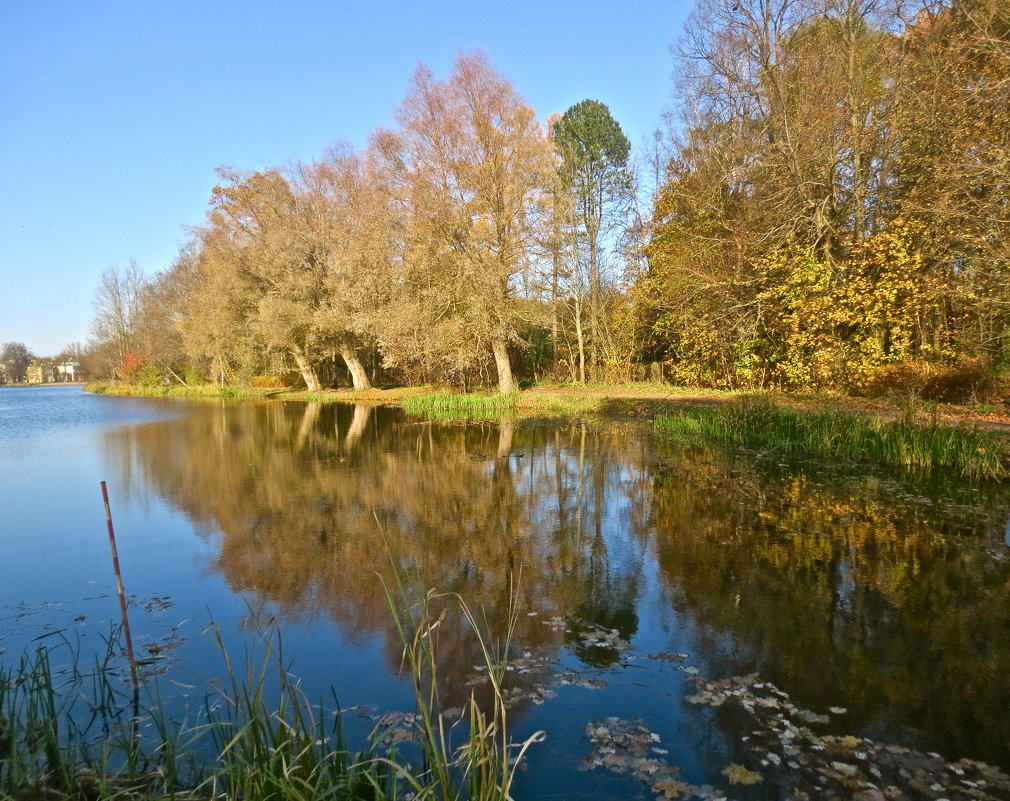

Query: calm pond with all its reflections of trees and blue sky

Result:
[0,387,1010,798]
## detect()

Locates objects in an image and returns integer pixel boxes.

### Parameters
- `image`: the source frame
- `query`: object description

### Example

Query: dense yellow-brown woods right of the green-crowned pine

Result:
[636,0,1010,390]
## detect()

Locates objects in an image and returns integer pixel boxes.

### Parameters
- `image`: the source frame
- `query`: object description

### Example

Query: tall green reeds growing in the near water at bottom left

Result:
[0,586,540,801]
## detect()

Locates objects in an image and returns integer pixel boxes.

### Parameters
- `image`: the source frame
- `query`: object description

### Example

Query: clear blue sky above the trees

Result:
[0,0,692,356]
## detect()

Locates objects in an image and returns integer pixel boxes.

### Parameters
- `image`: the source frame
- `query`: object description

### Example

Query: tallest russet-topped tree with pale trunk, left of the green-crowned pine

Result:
[375,54,553,392]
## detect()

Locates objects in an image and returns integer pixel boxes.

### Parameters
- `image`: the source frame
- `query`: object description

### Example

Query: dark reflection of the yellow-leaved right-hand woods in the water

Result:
[651,450,1010,765]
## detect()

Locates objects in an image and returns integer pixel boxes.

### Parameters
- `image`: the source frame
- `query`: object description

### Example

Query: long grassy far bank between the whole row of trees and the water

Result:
[78,385,1010,479]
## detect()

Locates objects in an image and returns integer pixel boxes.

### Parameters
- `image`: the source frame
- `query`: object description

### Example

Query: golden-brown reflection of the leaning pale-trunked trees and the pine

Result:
[108,404,646,693]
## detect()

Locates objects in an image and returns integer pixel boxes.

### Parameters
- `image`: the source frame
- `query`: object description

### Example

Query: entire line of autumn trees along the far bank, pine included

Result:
[94,0,1010,391]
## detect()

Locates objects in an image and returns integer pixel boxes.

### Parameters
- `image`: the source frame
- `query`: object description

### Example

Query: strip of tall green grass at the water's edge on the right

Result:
[653,397,1010,479]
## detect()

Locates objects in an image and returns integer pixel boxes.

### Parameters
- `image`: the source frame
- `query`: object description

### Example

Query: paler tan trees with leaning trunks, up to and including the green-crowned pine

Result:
[94,54,630,392]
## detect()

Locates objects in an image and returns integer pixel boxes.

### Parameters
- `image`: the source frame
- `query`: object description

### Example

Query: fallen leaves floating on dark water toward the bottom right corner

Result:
[585,675,1010,801]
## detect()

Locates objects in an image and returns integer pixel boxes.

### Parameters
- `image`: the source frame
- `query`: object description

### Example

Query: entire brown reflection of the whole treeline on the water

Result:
[107,404,1010,766]
